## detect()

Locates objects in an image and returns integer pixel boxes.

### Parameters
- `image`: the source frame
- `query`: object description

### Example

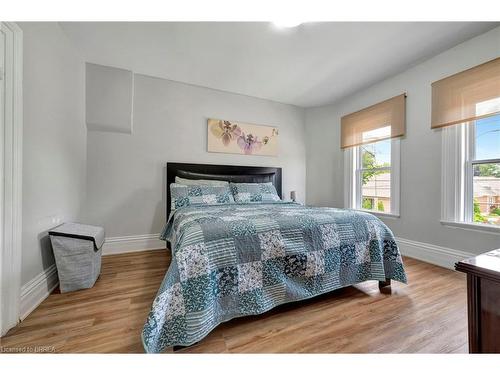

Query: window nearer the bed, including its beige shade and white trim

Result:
[342,94,405,216]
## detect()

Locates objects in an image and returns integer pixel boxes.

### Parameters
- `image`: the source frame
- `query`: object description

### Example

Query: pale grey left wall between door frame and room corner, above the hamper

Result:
[19,23,86,284]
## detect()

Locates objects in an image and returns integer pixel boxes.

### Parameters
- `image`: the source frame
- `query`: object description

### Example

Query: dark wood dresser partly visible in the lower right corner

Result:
[455,249,500,353]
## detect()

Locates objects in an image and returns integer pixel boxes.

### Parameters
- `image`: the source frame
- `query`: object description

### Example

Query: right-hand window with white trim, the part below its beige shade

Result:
[442,98,500,230]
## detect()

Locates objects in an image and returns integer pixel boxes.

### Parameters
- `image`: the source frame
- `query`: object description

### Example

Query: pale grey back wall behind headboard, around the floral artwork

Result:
[85,75,306,237]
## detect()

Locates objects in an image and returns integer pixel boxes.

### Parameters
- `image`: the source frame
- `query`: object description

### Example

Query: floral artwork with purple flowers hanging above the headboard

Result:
[207,119,279,156]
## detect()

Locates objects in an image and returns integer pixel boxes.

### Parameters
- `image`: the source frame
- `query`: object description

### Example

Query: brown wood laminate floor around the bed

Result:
[0,250,467,354]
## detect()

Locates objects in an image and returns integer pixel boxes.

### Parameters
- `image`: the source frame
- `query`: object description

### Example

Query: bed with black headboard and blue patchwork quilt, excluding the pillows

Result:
[142,163,407,353]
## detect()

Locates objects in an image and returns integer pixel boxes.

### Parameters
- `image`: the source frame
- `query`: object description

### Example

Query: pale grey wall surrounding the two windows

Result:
[306,28,500,253]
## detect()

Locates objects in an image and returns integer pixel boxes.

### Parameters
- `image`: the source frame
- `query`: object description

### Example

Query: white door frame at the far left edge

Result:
[0,22,23,336]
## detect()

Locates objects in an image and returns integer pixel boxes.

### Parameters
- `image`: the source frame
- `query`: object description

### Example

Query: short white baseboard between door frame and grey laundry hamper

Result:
[19,264,59,320]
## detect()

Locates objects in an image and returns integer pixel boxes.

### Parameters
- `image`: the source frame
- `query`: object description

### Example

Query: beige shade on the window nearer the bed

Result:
[340,94,406,148]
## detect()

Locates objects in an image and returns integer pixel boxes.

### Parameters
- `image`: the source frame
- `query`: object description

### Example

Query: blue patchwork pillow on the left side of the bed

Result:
[170,183,234,211]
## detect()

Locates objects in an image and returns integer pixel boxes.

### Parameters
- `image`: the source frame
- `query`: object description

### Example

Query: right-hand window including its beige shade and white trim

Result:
[432,59,500,232]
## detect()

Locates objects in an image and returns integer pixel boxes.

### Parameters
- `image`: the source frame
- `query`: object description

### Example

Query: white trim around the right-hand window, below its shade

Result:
[441,123,500,234]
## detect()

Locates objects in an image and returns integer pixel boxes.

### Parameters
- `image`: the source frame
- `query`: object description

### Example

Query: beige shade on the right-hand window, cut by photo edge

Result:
[431,58,500,129]
